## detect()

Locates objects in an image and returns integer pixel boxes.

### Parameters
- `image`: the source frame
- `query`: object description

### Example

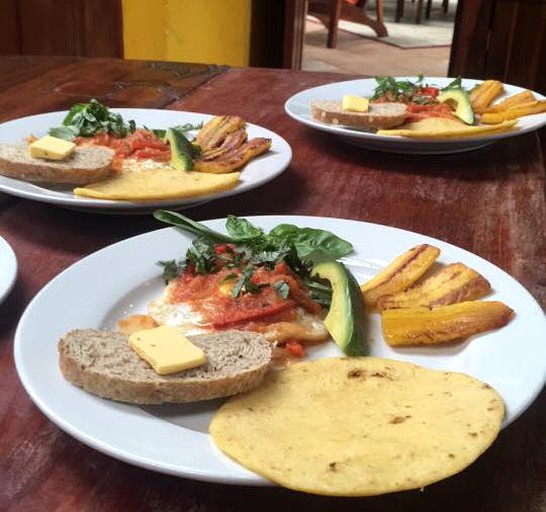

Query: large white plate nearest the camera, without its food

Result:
[15,216,546,485]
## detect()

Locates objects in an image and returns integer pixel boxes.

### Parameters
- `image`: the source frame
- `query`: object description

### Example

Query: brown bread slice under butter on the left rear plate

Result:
[0,144,114,185]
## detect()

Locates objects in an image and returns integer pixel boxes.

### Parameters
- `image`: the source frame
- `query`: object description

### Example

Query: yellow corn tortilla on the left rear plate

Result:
[74,168,240,201]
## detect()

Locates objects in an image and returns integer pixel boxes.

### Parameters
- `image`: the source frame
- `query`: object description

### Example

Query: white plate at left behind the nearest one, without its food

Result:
[0,108,292,213]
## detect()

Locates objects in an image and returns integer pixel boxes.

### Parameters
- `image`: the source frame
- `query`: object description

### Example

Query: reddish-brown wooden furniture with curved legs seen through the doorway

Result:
[307,0,388,48]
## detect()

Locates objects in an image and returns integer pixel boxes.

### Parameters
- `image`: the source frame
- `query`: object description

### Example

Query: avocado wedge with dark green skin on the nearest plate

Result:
[313,261,368,356]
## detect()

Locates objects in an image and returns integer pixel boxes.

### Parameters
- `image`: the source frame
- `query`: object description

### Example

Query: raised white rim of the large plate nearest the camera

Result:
[14,215,546,486]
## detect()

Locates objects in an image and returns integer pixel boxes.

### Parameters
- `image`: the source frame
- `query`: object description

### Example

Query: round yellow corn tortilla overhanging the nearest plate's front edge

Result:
[210,358,504,496]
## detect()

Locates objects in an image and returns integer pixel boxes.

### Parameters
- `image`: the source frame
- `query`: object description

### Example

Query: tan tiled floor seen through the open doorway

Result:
[302,1,450,76]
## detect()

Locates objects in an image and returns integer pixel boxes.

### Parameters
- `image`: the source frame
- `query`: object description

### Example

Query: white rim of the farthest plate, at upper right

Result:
[284,76,546,149]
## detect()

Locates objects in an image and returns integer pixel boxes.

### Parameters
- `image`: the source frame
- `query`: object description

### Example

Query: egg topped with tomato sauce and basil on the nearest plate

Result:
[150,210,360,355]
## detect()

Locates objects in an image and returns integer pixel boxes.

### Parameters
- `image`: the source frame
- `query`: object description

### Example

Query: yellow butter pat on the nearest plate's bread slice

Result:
[129,325,206,375]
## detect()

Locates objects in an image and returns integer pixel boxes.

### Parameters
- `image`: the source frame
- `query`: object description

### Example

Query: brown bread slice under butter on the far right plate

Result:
[311,100,407,131]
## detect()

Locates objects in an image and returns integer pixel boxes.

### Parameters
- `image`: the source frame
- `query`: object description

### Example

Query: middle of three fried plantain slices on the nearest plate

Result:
[377,263,491,310]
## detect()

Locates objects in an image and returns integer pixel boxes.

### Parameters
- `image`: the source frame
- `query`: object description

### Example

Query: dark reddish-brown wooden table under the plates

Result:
[0,57,546,512]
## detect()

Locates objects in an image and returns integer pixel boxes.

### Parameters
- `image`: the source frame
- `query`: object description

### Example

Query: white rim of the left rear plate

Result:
[0,107,293,214]
